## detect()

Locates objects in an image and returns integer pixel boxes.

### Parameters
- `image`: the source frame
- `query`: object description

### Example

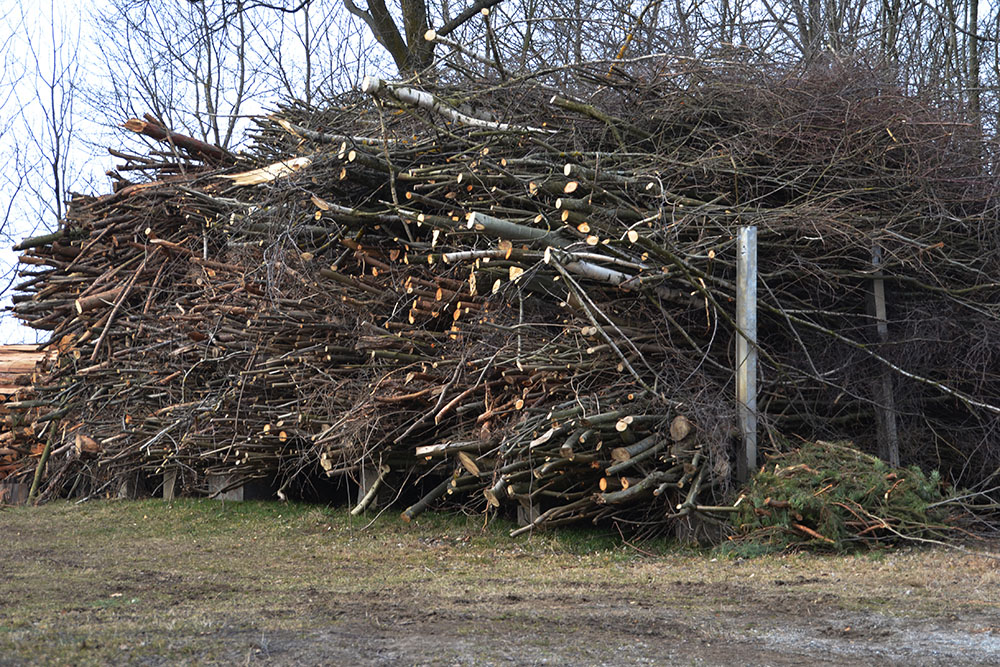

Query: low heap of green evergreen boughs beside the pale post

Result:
[734,441,954,551]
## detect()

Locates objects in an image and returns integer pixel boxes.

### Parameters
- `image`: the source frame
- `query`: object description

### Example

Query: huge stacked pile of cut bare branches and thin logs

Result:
[7,59,1000,531]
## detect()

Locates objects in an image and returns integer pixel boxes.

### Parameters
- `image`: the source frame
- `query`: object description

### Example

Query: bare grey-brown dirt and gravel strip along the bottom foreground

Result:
[255,599,1000,665]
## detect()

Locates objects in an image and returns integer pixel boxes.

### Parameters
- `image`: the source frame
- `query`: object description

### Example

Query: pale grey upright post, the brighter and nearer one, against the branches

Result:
[736,226,757,482]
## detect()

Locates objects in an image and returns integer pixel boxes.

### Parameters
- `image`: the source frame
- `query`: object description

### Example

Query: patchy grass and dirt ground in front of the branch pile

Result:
[0,500,1000,665]
